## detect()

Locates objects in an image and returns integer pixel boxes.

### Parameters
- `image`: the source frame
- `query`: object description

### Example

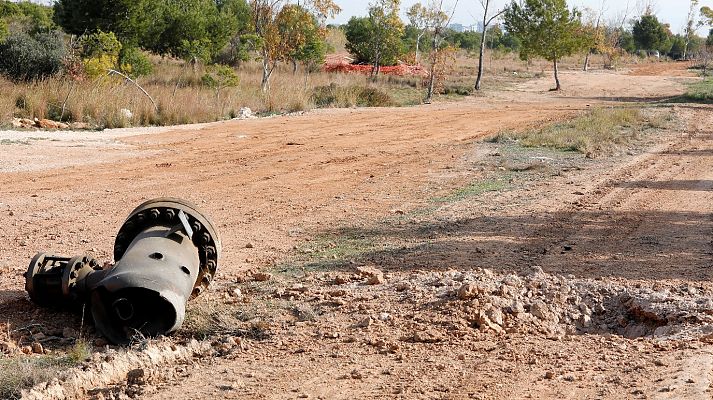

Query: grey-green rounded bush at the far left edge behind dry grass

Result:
[0,32,67,81]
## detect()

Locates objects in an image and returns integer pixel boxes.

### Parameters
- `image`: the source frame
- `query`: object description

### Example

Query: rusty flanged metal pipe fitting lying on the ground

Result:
[25,198,221,344]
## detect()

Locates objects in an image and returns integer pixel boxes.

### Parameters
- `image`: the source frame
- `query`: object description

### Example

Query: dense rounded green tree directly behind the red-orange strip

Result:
[345,0,404,77]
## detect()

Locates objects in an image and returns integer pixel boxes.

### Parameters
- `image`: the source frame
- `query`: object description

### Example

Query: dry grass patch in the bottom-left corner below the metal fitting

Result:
[0,341,91,400]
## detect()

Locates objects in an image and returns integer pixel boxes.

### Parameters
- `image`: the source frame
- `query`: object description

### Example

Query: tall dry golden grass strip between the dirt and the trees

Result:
[0,50,628,129]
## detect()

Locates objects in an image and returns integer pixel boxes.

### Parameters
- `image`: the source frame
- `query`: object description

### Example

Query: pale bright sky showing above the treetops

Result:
[332,0,713,36]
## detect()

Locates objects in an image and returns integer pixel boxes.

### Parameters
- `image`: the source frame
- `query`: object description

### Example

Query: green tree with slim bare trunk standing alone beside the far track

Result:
[504,0,589,90]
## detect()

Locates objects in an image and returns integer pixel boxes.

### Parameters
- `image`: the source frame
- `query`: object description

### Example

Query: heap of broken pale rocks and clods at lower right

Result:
[394,267,713,339]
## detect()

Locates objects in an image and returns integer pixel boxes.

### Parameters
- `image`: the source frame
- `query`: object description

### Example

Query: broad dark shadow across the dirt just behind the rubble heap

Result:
[312,206,713,281]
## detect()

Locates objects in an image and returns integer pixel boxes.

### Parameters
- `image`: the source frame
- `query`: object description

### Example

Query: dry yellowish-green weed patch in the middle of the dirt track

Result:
[487,108,672,158]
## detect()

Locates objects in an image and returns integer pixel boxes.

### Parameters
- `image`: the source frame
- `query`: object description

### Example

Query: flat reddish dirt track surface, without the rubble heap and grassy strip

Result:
[0,62,713,399]
